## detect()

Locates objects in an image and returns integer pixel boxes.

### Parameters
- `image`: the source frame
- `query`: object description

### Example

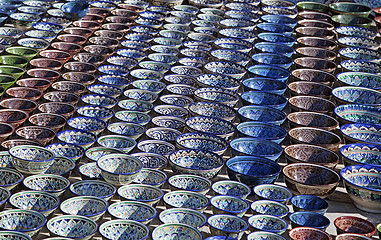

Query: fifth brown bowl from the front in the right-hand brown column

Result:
[288,96,336,114]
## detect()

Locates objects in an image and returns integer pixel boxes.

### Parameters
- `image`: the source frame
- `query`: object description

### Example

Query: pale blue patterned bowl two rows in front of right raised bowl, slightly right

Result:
[107,201,157,224]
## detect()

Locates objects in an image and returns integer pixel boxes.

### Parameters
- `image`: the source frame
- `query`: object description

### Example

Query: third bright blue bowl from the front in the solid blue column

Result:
[237,122,287,143]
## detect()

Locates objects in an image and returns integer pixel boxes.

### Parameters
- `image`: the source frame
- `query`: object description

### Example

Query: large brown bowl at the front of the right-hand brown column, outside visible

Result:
[283,163,340,198]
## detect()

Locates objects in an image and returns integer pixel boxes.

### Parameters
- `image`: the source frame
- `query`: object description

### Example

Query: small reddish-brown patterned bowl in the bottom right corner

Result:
[334,216,376,237]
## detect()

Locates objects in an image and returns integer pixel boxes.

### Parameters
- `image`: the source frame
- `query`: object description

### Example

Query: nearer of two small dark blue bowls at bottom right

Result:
[288,212,331,231]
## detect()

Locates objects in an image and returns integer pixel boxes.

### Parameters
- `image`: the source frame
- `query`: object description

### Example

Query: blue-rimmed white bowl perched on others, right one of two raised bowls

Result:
[97,154,143,186]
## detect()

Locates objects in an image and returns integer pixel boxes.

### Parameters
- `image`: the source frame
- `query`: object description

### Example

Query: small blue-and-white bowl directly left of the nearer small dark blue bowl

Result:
[248,215,288,234]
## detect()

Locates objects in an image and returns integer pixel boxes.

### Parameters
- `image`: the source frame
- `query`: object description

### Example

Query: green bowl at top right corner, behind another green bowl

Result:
[329,2,372,17]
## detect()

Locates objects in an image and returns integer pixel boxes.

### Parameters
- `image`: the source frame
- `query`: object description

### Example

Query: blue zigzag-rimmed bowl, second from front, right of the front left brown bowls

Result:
[57,130,97,150]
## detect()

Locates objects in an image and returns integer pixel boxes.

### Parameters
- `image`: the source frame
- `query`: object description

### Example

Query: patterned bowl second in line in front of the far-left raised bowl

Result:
[9,191,60,216]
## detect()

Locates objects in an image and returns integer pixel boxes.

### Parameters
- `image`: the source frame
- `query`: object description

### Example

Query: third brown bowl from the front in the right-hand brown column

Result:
[288,127,342,151]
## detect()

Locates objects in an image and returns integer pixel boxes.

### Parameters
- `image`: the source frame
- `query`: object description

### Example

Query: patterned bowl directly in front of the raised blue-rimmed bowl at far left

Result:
[23,174,70,197]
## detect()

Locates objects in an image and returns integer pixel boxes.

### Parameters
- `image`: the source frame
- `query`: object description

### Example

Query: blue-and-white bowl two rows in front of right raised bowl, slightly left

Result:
[60,196,108,221]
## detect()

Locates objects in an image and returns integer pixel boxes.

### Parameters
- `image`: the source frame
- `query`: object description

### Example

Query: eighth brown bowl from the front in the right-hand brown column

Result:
[294,57,337,73]
